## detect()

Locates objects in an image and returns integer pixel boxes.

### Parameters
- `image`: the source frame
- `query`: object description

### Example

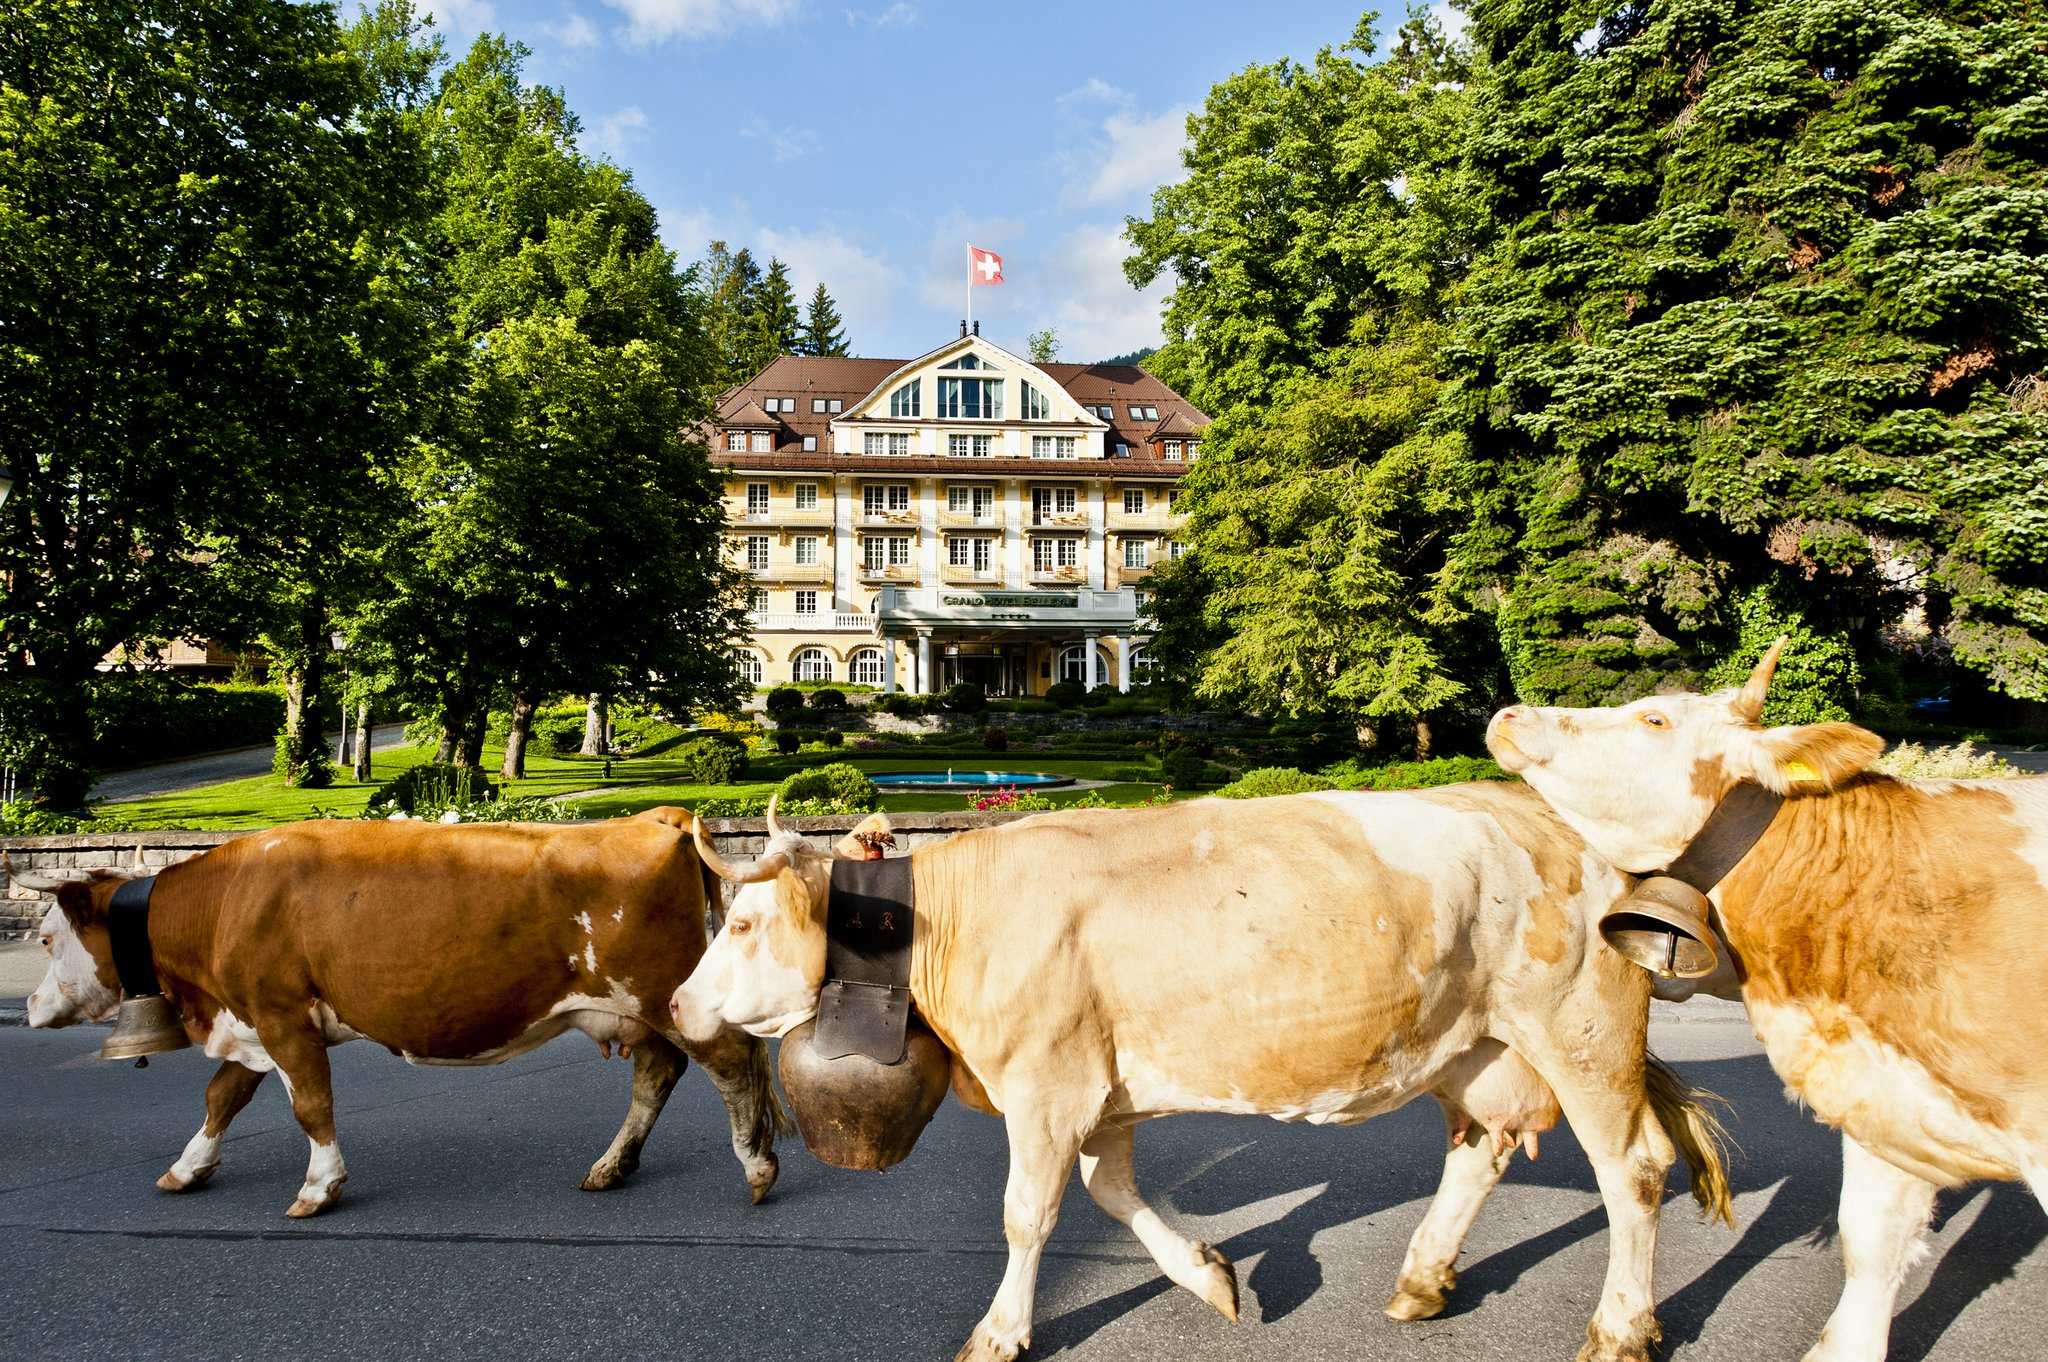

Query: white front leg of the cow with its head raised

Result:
[1806,1135,1935,1362]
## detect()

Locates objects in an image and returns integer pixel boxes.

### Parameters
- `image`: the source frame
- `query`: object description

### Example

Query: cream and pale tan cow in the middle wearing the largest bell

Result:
[674,798,1726,1362]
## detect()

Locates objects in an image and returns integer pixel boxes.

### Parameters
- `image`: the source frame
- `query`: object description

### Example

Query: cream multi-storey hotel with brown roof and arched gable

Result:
[711,328,1208,694]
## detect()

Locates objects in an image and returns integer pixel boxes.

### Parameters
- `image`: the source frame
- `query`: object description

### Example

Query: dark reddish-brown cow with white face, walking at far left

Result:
[29,809,780,1217]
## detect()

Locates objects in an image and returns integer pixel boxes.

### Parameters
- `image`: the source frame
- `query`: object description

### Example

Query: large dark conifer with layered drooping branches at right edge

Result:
[1456,0,2048,703]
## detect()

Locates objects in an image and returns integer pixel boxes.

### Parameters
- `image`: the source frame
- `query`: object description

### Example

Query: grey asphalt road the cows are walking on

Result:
[0,1018,2048,1362]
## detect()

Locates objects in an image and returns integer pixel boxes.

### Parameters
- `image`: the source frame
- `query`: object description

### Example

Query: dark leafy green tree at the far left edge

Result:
[0,0,410,807]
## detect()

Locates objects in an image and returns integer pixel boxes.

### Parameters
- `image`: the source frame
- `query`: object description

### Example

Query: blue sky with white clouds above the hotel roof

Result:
[420,0,1458,360]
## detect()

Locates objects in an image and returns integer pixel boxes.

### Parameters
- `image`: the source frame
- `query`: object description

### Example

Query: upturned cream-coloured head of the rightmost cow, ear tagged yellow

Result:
[1487,639,1884,875]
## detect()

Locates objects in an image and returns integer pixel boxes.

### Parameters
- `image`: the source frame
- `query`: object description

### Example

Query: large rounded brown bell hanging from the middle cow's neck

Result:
[776,1020,952,1172]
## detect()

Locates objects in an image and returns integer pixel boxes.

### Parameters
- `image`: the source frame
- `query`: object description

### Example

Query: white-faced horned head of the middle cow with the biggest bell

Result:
[670,801,891,1040]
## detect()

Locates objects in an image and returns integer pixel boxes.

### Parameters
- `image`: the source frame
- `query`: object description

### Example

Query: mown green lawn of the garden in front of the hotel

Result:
[98,748,1187,829]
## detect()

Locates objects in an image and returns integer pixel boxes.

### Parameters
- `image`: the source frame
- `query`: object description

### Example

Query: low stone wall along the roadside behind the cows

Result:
[0,813,1024,940]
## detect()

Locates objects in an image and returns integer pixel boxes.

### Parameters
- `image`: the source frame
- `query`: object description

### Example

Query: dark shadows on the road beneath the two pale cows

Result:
[1036,1055,2048,1362]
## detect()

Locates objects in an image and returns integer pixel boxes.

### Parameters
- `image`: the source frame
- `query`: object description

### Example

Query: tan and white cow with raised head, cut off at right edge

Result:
[1487,639,2048,1362]
